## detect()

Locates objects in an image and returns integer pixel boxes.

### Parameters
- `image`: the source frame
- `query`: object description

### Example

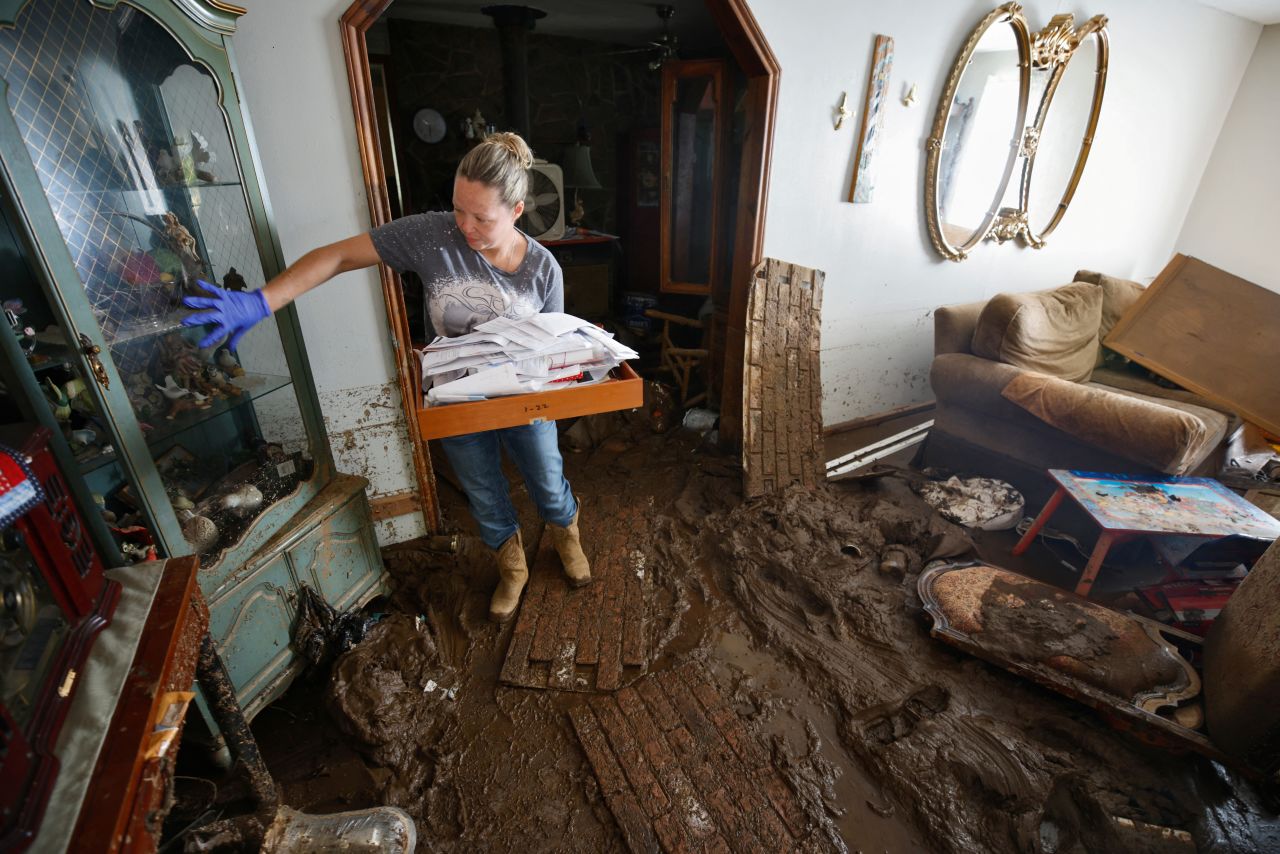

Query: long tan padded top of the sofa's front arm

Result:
[1001,373,1228,475]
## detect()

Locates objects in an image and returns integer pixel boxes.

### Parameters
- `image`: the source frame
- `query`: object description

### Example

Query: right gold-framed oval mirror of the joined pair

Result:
[1019,14,1110,248]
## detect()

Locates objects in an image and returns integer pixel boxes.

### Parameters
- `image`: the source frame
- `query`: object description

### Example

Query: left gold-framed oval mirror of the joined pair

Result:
[924,3,1030,261]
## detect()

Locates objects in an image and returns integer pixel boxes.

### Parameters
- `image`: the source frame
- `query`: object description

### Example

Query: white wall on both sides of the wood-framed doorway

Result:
[236,0,1259,542]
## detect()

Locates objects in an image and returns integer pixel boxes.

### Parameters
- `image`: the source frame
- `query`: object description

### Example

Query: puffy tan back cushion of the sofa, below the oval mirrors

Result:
[972,282,1102,382]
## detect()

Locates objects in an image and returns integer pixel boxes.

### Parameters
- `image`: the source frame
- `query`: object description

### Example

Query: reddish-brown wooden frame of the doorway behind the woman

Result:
[339,0,782,531]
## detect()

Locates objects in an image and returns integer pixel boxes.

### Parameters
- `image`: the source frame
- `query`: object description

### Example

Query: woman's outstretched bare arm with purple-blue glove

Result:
[182,234,380,350]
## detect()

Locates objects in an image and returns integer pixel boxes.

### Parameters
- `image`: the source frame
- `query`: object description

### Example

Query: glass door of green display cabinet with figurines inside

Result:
[0,0,315,566]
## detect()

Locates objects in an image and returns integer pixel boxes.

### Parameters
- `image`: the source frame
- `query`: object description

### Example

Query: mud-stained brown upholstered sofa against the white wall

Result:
[918,270,1238,498]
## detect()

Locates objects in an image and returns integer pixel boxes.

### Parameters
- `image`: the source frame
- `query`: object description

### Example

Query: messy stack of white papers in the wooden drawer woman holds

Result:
[420,311,639,403]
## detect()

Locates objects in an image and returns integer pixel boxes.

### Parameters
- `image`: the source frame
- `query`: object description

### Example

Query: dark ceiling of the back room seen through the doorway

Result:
[384,0,721,49]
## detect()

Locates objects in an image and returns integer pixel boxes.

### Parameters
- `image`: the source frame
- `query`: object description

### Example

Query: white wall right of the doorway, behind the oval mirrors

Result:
[750,0,1254,425]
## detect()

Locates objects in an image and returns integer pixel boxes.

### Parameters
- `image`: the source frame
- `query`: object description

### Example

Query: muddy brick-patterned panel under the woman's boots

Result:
[499,507,649,691]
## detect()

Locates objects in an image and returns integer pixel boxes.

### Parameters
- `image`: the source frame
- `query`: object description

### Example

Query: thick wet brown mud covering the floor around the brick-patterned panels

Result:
[241,420,1280,853]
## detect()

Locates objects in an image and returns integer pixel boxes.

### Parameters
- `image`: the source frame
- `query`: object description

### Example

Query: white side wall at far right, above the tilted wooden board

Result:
[1178,24,1280,291]
